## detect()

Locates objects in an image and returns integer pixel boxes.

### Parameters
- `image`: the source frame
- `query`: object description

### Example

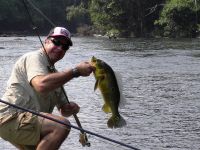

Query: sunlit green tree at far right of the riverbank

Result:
[155,0,199,37]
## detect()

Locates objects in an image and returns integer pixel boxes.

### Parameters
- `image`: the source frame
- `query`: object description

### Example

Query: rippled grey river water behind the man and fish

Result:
[0,37,200,150]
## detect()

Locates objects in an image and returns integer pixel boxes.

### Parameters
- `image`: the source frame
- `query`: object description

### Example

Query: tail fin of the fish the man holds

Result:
[107,115,126,128]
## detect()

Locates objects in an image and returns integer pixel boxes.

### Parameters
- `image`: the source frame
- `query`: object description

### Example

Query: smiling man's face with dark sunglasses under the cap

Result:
[45,36,69,63]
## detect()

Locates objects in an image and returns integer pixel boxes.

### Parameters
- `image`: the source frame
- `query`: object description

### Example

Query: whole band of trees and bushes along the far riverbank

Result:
[0,0,200,37]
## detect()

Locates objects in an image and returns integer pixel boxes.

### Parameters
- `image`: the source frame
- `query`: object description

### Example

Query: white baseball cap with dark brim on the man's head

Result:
[47,27,72,46]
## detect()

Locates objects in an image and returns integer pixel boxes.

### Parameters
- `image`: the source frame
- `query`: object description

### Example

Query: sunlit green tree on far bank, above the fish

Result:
[89,0,125,37]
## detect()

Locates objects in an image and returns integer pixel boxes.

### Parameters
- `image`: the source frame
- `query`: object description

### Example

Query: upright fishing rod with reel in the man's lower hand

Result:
[23,0,90,147]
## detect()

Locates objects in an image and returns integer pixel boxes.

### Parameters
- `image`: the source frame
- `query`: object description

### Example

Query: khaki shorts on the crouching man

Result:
[0,112,43,150]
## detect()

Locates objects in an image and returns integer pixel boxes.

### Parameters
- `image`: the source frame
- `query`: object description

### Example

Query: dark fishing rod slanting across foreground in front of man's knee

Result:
[0,99,140,150]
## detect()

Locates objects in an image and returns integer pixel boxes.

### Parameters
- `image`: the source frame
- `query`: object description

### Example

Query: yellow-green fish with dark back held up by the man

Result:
[91,56,126,128]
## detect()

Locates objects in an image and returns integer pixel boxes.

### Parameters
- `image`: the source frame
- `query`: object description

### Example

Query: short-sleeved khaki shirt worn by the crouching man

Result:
[0,50,67,118]
